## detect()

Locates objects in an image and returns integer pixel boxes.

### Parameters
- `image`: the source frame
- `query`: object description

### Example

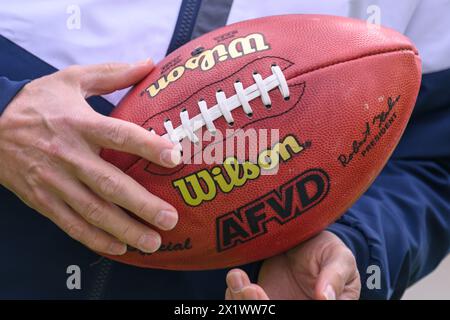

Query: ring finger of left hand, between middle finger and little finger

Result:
[50,171,161,253]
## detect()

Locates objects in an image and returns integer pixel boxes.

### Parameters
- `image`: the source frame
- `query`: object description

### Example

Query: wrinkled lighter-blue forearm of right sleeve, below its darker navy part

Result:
[329,160,450,299]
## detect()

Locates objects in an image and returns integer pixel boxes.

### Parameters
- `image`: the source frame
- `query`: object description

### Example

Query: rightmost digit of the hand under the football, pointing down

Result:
[315,246,357,300]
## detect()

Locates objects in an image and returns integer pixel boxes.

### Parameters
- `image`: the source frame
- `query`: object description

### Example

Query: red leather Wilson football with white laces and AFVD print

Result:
[102,15,421,270]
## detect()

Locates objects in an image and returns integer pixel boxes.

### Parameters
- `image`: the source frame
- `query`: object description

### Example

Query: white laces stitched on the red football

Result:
[163,65,289,144]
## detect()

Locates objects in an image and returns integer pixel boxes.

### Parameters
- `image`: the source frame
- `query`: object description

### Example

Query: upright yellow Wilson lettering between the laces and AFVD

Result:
[172,135,305,207]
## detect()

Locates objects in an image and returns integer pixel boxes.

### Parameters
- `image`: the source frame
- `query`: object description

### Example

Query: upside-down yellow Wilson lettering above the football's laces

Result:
[145,33,270,97]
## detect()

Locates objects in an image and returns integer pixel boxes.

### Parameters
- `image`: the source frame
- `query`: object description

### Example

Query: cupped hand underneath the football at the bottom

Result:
[225,231,361,300]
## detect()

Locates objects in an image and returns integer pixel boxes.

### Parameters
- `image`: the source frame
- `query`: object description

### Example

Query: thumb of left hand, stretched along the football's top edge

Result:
[76,59,153,98]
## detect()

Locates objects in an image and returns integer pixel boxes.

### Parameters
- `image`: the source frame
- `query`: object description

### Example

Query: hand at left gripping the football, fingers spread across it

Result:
[0,60,181,255]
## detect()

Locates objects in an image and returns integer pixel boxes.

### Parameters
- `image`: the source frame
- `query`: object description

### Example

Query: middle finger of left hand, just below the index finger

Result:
[77,156,178,230]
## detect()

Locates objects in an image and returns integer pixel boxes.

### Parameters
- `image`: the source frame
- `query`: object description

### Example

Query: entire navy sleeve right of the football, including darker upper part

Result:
[328,70,450,299]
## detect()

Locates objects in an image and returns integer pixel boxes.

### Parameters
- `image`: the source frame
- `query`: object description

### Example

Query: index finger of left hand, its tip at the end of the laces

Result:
[85,115,181,168]
